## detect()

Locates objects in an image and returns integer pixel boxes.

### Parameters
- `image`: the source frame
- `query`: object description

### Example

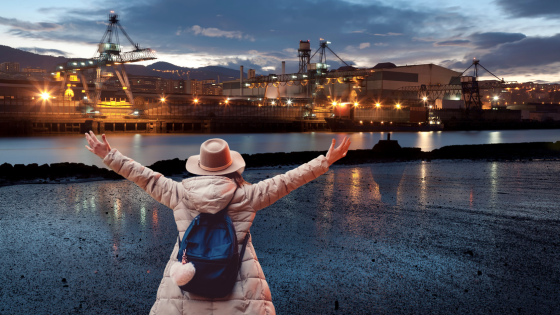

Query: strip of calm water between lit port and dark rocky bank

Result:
[0,129,560,166]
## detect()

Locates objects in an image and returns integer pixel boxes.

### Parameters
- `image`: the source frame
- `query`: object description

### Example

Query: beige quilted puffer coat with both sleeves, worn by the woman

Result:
[103,149,329,315]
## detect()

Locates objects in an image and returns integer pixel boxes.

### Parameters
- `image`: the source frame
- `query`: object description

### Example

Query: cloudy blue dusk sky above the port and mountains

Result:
[0,0,560,82]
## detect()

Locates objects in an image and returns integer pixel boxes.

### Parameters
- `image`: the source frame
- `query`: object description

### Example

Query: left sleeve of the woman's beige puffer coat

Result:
[103,149,185,209]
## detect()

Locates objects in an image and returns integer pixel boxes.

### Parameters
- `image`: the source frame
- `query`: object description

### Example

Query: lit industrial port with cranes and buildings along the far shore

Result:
[0,13,560,136]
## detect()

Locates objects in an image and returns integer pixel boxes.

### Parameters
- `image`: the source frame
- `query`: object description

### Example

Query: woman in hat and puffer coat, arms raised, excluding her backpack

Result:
[86,131,350,315]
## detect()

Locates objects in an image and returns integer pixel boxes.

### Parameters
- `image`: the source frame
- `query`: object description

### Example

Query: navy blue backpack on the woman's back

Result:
[177,209,251,298]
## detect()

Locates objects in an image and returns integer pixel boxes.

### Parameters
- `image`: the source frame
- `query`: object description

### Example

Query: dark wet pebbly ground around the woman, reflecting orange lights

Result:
[0,161,560,314]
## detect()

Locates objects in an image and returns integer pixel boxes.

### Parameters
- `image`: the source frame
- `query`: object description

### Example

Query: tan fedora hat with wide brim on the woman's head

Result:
[186,138,245,175]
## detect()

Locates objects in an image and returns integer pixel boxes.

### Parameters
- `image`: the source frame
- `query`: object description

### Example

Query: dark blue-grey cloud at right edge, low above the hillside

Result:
[443,34,560,74]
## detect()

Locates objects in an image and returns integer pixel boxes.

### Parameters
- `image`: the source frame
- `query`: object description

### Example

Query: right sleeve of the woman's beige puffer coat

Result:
[245,155,329,211]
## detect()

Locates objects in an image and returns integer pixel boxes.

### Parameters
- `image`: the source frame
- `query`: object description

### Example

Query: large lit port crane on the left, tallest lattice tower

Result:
[56,11,157,113]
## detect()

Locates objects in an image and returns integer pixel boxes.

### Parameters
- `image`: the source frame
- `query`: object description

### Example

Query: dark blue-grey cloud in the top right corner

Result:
[496,0,560,17]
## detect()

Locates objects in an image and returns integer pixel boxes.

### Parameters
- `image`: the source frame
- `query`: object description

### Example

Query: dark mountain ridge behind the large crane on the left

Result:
[0,45,247,82]
